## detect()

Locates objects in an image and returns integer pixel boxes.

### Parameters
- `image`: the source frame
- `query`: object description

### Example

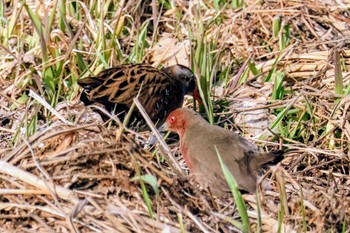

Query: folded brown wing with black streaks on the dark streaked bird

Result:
[79,64,179,106]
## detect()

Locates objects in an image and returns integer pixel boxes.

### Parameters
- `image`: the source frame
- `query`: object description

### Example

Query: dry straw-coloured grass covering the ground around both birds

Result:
[0,1,350,232]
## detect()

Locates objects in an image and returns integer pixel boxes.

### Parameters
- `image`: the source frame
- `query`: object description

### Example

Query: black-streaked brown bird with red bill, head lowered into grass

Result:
[78,64,202,131]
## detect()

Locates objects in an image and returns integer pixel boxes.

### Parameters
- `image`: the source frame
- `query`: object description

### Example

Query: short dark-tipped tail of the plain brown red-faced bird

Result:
[250,150,284,171]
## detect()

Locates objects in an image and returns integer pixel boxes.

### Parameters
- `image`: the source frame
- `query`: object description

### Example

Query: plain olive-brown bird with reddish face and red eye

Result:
[164,108,284,197]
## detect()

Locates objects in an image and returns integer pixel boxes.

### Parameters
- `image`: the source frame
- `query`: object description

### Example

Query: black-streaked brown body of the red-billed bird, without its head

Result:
[79,64,184,125]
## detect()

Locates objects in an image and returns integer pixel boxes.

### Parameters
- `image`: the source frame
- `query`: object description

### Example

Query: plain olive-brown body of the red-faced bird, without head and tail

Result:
[185,123,257,195]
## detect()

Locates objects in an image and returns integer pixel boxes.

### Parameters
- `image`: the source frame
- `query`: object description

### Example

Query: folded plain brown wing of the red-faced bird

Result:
[187,125,257,192]
